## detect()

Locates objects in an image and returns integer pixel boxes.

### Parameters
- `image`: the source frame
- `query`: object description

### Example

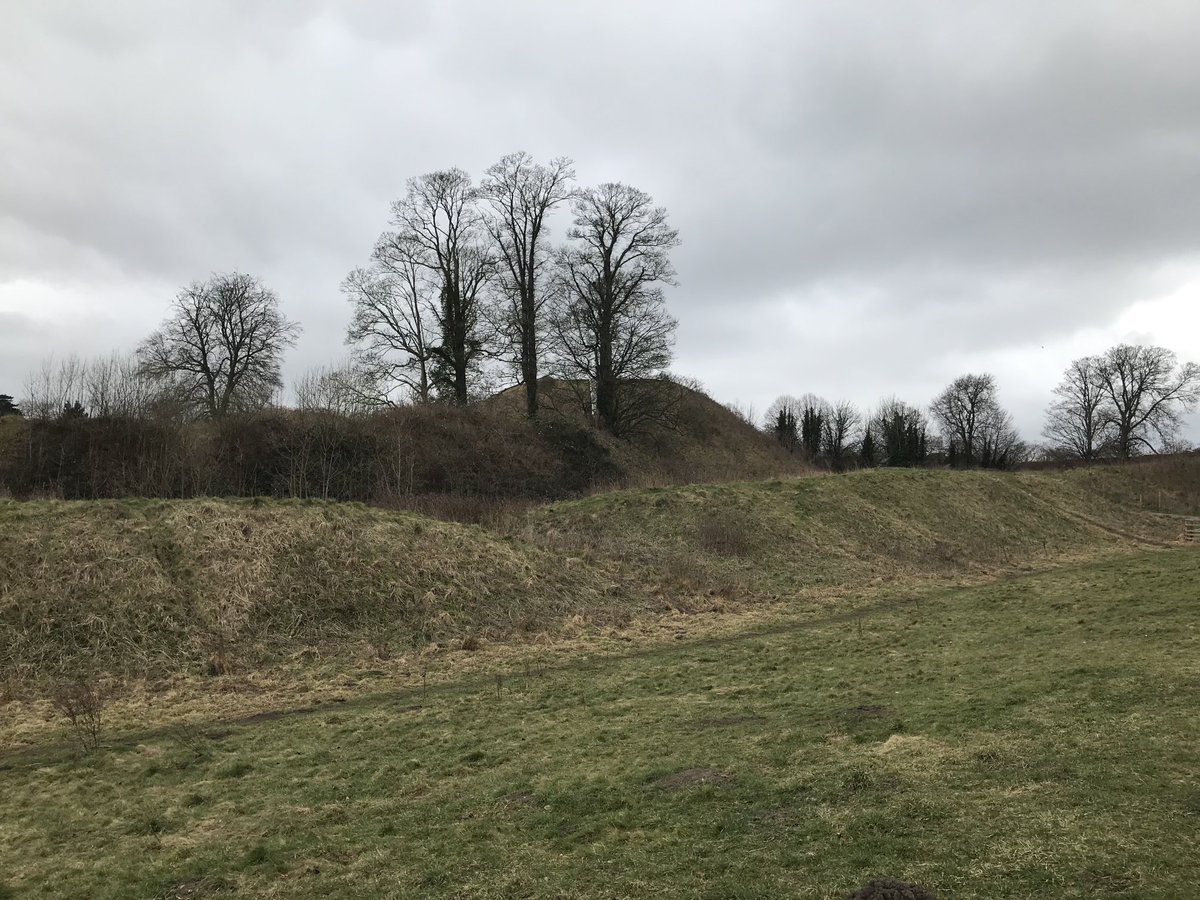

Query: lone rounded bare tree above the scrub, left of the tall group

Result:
[138,272,300,418]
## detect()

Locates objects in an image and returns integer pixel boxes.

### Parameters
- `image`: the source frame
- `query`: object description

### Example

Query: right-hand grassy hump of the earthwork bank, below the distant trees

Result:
[530,469,1178,607]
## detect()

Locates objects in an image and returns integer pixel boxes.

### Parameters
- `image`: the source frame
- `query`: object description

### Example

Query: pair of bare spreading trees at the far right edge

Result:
[1043,344,1200,460]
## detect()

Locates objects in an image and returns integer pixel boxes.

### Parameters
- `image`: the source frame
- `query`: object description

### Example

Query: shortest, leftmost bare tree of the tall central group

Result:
[342,233,438,403]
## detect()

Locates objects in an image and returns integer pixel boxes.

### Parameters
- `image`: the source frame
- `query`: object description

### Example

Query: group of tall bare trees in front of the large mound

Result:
[338,152,678,433]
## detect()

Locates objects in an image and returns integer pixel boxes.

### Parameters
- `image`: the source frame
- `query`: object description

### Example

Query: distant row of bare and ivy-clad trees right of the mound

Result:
[762,344,1200,472]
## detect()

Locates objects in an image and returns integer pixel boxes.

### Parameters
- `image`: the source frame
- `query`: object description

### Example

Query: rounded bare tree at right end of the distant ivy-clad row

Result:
[930,374,1020,468]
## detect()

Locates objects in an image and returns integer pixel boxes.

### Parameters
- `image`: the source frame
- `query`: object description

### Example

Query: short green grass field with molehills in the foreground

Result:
[0,548,1200,899]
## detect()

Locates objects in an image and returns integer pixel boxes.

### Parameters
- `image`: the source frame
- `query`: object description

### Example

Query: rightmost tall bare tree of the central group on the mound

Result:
[552,182,679,434]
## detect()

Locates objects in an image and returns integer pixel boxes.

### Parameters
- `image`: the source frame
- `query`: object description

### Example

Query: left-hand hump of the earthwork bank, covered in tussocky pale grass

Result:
[0,500,624,676]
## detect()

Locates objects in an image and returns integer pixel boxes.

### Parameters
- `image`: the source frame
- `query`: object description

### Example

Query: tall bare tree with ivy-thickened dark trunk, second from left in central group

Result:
[380,169,496,406]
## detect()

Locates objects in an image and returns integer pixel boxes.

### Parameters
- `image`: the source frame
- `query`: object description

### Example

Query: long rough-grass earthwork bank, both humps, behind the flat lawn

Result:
[0,470,1177,677]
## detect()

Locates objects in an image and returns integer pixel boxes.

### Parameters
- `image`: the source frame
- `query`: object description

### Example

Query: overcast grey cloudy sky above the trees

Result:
[0,0,1200,440]
